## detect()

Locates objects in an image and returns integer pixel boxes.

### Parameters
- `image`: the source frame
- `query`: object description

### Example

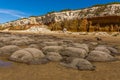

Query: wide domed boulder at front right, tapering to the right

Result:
[86,50,116,61]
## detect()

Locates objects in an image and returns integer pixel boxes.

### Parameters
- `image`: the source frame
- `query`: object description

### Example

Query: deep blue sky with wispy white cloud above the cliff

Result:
[0,0,120,23]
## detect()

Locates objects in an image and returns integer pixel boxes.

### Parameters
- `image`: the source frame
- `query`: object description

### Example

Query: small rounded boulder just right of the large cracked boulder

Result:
[46,52,62,61]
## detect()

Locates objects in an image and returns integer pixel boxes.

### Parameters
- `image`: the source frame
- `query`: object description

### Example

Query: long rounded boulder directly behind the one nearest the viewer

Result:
[60,47,88,58]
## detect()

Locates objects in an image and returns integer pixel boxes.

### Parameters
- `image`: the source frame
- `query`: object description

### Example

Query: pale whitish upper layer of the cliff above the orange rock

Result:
[0,4,120,27]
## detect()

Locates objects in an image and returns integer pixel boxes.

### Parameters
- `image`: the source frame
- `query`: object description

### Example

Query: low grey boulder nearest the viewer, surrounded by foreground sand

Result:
[61,58,95,70]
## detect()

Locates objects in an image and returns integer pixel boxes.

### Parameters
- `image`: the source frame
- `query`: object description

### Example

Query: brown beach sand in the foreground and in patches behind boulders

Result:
[0,32,120,80]
